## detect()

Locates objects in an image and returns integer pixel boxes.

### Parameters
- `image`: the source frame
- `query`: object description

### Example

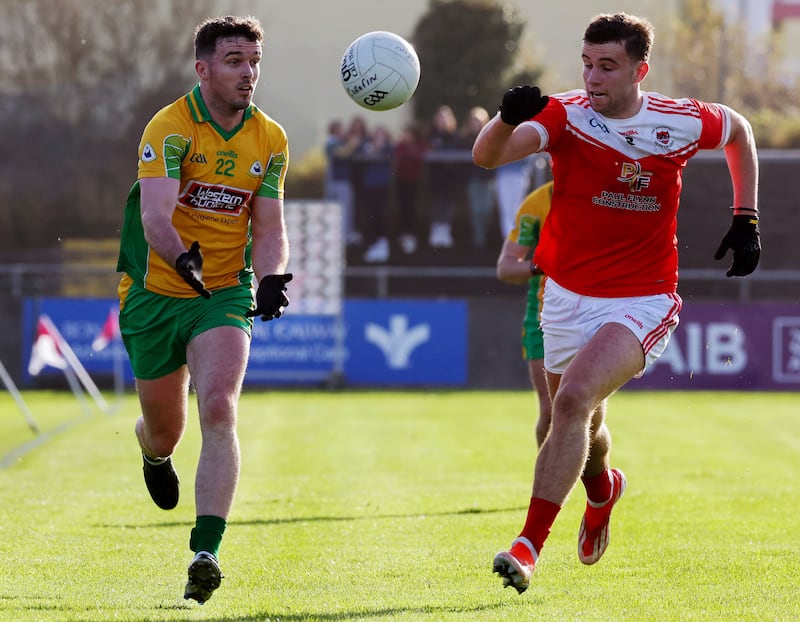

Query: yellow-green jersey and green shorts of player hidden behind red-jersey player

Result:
[508,181,553,360]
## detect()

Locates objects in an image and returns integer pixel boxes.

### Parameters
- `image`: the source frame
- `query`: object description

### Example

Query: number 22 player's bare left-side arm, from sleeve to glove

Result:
[139,177,187,266]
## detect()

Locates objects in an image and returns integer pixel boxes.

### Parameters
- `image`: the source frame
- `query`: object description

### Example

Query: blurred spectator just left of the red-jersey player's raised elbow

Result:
[459,106,494,251]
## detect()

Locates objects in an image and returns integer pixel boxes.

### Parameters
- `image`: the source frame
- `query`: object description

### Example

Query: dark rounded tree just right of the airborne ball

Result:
[411,0,542,127]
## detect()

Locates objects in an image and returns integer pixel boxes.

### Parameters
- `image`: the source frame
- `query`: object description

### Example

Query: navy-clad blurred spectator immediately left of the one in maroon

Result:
[358,126,394,263]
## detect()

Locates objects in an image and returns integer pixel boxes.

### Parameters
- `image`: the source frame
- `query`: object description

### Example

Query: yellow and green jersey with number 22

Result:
[112,85,289,302]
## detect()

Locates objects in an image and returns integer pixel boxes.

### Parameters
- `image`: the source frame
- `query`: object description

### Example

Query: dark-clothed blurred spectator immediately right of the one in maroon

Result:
[427,105,462,248]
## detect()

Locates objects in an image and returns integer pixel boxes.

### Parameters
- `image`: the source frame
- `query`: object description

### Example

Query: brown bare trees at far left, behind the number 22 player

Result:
[0,0,214,251]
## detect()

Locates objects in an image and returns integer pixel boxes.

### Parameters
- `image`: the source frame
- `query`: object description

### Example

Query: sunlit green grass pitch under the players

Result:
[0,392,800,622]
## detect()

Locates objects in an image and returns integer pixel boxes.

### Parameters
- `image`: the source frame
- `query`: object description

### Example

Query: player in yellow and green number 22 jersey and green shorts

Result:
[117,17,292,604]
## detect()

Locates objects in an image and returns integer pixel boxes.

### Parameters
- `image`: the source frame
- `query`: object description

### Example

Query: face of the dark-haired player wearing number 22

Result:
[198,37,261,110]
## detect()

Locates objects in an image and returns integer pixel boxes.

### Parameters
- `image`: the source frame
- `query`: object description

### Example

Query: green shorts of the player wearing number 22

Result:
[119,285,253,380]
